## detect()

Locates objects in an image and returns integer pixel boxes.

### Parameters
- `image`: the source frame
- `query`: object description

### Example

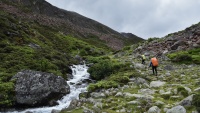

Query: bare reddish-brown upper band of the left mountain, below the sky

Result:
[1,0,144,50]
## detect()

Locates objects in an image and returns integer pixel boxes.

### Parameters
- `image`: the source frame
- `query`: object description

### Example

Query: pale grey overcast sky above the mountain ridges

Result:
[46,0,200,39]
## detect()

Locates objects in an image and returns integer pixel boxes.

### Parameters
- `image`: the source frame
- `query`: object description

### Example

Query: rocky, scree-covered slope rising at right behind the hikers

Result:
[134,23,200,56]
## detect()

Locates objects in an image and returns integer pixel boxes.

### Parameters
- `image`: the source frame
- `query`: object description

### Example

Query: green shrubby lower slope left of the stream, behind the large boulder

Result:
[0,11,107,107]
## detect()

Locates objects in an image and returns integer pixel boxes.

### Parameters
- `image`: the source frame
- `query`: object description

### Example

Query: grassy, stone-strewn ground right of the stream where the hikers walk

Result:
[61,44,200,113]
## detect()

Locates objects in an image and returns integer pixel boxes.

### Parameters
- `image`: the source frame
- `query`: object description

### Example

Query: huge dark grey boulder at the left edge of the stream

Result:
[12,70,70,107]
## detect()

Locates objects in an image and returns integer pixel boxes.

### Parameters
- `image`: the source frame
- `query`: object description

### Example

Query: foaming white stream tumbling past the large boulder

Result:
[13,64,89,113]
